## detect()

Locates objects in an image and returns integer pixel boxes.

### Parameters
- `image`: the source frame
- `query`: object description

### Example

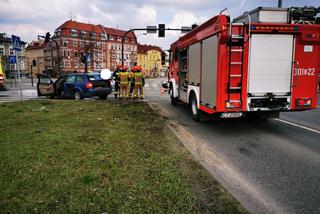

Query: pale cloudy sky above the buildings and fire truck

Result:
[0,0,320,49]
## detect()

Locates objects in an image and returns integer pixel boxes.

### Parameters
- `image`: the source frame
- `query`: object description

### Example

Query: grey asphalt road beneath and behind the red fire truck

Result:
[145,79,320,214]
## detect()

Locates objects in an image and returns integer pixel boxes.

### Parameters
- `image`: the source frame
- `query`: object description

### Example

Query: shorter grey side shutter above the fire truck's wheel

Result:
[189,42,201,85]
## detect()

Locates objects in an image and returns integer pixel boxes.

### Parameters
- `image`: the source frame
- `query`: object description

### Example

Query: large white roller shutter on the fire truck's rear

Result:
[248,34,293,96]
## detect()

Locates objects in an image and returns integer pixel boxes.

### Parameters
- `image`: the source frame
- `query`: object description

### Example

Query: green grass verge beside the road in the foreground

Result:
[0,100,246,213]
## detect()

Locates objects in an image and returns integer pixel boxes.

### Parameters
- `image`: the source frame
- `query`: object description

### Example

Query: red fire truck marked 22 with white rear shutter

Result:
[168,7,320,120]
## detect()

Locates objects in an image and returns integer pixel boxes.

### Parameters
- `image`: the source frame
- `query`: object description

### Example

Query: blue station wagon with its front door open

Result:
[37,73,112,100]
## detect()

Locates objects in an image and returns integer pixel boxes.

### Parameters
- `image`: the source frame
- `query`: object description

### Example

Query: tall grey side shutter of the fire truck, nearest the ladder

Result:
[201,36,218,108]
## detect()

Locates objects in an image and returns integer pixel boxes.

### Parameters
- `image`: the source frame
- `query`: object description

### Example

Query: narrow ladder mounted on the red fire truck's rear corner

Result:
[227,23,244,106]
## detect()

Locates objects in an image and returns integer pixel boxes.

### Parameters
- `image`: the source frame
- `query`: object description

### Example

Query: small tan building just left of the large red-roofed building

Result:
[25,40,45,76]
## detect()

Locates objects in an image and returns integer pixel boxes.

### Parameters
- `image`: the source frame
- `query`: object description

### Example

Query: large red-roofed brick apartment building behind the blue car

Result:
[44,20,137,74]
